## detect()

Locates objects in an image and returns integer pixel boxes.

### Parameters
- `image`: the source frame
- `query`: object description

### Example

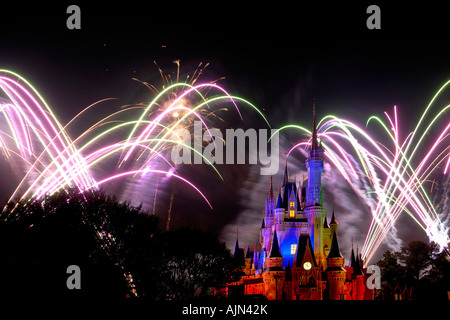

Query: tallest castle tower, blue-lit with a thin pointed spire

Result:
[304,104,326,265]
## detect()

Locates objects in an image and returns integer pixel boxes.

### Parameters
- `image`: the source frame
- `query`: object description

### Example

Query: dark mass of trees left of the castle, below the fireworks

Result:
[0,192,236,301]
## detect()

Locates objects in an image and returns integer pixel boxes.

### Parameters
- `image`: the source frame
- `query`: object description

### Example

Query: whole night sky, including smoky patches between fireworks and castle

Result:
[0,1,450,257]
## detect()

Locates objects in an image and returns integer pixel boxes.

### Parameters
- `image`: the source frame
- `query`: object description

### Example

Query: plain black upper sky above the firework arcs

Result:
[0,2,449,122]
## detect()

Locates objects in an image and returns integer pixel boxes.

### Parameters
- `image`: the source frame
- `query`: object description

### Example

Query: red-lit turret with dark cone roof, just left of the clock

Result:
[263,230,286,300]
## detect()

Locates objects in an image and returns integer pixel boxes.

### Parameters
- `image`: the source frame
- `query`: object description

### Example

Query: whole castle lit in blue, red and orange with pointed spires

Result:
[225,105,373,300]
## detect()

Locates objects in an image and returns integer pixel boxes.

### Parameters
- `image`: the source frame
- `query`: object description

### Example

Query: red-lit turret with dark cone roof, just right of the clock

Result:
[325,232,346,300]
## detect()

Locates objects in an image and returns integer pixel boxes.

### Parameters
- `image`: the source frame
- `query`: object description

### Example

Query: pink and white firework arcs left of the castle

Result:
[0,61,263,212]
